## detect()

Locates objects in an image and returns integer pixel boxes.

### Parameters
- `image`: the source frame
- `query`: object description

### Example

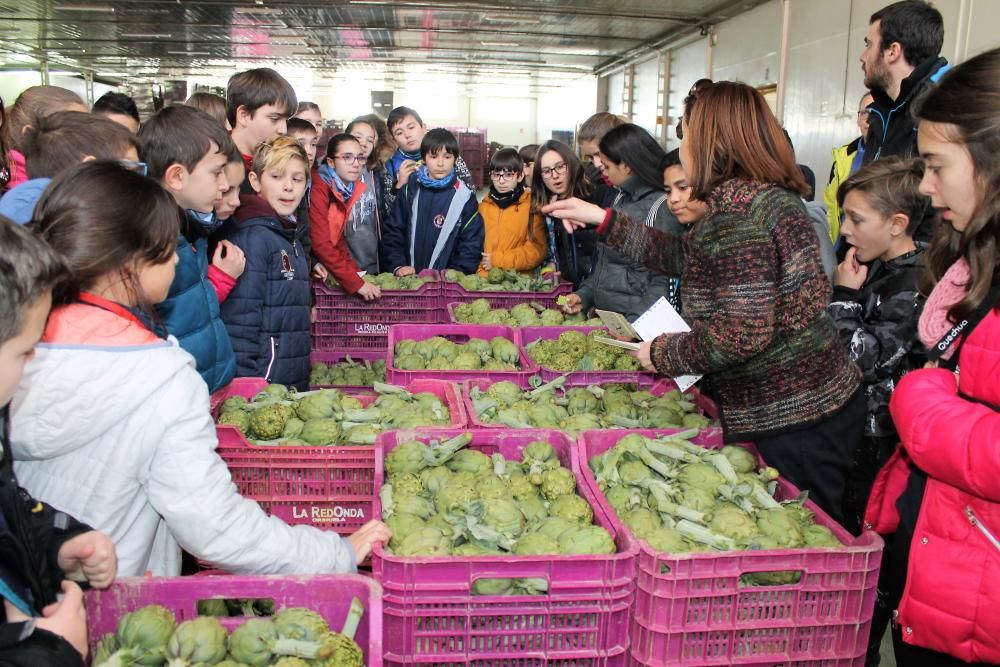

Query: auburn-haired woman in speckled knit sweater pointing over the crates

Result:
[543,82,865,520]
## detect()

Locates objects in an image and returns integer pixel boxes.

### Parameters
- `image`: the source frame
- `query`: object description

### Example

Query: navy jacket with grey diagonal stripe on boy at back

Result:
[382,174,486,273]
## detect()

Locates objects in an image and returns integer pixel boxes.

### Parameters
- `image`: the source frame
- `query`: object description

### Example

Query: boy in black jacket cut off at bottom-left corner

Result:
[0,218,117,667]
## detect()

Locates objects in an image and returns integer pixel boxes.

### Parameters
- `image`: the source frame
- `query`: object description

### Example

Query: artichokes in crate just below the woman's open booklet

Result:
[525,329,642,373]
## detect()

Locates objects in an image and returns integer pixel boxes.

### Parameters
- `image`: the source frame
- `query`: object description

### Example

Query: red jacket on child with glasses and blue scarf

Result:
[309,169,365,294]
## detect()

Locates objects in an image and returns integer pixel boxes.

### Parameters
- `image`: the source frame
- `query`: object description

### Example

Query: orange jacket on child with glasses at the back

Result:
[479,190,546,276]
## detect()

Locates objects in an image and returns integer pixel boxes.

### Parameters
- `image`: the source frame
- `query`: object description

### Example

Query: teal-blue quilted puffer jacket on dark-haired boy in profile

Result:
[156,213,236,392]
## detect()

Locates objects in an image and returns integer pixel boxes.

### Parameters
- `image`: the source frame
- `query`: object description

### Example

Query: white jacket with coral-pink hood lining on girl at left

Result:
[11,299,355,576]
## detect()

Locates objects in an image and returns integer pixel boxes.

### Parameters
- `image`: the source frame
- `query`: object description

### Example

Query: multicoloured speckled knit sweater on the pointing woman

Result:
[602,178,861,441]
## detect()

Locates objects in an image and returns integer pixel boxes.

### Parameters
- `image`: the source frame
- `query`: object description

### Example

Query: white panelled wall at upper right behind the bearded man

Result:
[608,0,1000,182]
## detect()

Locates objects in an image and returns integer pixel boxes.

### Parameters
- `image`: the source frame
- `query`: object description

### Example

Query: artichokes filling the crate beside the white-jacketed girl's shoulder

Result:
[216,382,451,447]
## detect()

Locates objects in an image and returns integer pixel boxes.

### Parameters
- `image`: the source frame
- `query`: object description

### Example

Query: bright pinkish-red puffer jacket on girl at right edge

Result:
[865,311,1000,663]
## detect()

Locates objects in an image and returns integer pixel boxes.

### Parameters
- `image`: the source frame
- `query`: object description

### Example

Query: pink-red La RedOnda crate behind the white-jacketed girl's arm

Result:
[212,378,467,535]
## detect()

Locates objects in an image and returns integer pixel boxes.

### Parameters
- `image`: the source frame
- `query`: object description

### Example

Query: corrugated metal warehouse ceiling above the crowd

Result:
[0,0,763,83]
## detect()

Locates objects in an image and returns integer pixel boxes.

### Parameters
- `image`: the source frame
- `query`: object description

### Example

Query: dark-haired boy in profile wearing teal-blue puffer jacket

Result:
[139,105,245,393]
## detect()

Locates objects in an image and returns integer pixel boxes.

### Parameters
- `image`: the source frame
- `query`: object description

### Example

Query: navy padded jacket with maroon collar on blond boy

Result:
[222,195,311,389]
